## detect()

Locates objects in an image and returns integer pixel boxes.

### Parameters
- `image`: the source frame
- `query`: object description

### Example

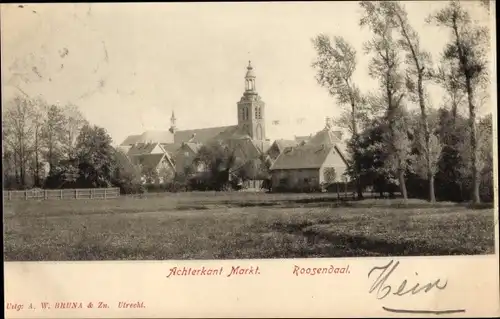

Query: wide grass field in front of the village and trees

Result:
[4,193,494,261]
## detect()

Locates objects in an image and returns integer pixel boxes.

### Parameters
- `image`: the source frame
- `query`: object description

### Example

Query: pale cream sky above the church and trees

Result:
[1,1,488,143]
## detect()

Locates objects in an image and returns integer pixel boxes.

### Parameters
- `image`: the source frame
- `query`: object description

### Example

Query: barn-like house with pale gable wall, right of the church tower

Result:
[270,126,348,191]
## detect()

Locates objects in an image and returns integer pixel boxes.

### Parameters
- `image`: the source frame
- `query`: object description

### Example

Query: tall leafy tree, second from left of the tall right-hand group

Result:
[360,1,410,200]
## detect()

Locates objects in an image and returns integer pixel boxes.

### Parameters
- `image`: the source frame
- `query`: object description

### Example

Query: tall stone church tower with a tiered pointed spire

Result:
[237,61,266,140]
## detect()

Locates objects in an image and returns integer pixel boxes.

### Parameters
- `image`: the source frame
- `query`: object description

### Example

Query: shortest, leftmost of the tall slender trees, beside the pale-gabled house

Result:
[312,34,363,199]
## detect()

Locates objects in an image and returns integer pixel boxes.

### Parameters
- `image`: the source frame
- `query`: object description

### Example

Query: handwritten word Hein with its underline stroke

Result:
[368,260,465,314]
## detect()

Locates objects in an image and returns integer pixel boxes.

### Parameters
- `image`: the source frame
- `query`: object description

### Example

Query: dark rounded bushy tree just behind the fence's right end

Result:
[76,125,115,187]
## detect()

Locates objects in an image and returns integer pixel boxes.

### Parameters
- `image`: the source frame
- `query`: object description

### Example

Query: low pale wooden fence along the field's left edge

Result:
[3,188,120,201]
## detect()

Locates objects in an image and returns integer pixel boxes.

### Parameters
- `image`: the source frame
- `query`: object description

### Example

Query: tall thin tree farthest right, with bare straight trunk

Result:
[429,1,489,203]
